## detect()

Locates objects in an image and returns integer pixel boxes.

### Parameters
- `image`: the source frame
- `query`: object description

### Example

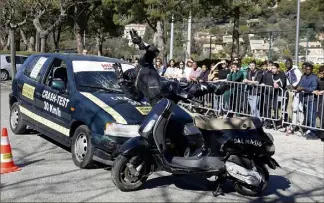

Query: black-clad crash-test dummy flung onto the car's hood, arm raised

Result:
[113,30,226,107]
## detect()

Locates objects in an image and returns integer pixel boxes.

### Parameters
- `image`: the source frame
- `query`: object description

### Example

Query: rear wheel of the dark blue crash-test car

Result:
[10,102,27,135]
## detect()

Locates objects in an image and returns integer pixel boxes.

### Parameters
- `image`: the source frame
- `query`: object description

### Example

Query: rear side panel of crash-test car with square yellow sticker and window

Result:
[17,56,48,129]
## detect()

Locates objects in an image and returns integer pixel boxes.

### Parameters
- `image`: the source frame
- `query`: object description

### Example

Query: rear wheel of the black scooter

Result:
[234,165,269,196]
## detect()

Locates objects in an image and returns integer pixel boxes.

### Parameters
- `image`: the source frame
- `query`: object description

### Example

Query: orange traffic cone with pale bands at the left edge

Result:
[0,128,21,174]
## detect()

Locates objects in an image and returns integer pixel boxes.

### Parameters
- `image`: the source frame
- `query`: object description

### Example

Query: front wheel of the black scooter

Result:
[111,155,148,192]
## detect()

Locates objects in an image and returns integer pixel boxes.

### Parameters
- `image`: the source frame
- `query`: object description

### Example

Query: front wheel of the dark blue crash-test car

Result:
[71,125,94,168]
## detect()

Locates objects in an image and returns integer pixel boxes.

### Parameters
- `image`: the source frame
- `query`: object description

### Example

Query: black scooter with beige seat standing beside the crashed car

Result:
[111,88,280,196]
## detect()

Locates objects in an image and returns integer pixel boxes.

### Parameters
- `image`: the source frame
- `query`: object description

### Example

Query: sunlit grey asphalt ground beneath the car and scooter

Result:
[0,83,324,202]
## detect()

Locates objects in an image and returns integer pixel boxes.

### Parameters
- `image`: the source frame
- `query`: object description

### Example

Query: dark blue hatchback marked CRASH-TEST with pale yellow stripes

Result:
[10,54,151,168]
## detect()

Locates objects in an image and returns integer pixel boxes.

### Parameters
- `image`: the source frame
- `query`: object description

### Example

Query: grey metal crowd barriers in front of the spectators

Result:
[168,81,324,132]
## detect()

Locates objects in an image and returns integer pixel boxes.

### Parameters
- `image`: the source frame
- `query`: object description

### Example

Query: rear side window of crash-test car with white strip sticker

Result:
[24,56,48,82]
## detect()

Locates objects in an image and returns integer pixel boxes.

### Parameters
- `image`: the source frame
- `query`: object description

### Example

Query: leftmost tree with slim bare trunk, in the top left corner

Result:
[0,0,27,78]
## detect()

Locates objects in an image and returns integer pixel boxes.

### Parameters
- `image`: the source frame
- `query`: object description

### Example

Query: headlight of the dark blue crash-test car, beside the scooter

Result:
[104,123,140,137]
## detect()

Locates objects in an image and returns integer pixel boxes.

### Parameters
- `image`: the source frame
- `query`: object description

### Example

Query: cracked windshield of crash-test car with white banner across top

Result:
[72,61,132,92]
